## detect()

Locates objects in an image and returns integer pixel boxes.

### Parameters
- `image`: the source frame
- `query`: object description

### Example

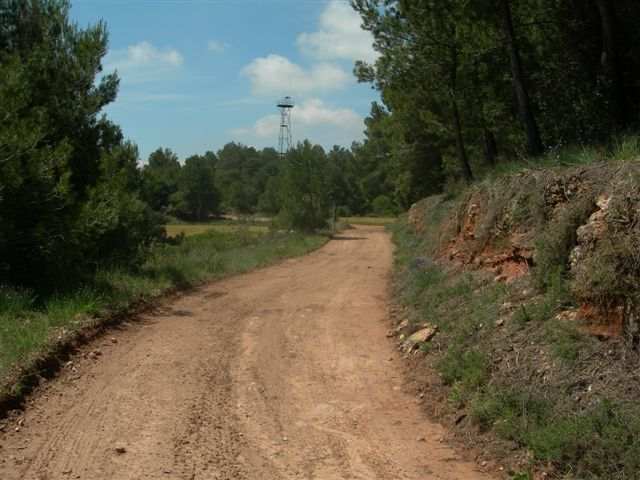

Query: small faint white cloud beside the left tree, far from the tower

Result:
[105,41,184,83]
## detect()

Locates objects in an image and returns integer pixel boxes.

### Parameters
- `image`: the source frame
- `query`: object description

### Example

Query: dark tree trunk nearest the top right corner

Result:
[596,0,629,127]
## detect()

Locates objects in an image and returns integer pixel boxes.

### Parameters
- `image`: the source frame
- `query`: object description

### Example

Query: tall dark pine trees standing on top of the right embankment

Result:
[352,0,640,207]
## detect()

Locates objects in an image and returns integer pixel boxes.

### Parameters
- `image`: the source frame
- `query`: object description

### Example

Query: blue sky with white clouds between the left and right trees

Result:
[72,0,378,160]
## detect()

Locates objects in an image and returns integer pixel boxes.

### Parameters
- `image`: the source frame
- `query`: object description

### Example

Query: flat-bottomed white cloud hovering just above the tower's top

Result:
[242,54,352,95]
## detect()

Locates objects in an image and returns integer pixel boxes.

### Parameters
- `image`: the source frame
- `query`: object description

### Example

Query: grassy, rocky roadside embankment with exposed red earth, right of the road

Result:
[389,137,640,479]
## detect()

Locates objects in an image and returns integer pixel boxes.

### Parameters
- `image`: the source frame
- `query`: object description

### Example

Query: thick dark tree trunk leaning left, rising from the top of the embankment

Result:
[500,0,544,156]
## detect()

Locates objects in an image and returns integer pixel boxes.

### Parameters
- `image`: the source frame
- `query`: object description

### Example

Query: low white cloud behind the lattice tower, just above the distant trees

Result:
[231,98,364,146]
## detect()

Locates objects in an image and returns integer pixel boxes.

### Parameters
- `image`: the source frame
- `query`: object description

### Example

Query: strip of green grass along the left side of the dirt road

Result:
[0,229,327,394]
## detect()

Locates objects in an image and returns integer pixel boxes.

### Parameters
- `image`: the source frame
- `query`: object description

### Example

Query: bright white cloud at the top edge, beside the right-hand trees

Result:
[297,0,378,62]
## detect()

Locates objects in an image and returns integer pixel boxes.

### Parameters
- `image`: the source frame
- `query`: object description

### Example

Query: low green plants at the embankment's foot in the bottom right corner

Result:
[472,387,640,479]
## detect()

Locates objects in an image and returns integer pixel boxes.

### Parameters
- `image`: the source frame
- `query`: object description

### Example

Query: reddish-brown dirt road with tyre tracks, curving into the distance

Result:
[0,227,496,480]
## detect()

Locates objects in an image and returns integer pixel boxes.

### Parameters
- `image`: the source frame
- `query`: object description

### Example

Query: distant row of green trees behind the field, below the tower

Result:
[141,141,397,228]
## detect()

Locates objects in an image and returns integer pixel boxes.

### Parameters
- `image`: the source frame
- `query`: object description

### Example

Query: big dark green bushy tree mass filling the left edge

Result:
[0,0,162,289]
